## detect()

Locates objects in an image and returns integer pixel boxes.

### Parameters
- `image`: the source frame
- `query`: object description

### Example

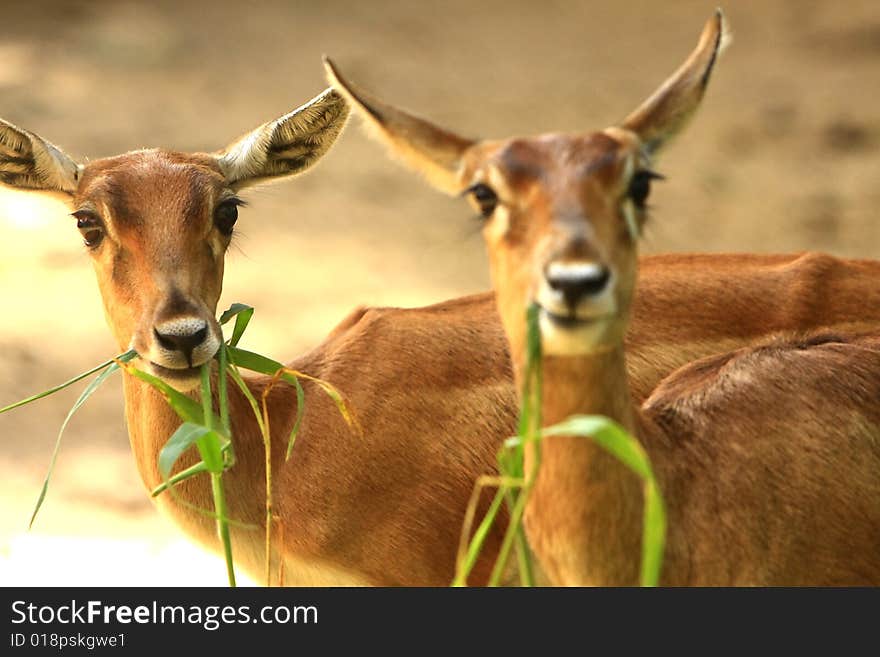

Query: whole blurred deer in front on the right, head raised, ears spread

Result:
[328,12,880,585]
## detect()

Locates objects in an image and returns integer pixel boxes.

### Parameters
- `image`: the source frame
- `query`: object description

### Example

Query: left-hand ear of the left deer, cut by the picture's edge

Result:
[0,119,82,194]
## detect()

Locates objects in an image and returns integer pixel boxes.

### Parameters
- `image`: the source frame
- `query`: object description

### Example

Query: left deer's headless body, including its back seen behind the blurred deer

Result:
[117,254,880,586]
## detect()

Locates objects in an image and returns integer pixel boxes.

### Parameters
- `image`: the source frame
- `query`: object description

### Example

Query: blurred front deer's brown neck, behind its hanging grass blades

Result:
[517,344,642,586]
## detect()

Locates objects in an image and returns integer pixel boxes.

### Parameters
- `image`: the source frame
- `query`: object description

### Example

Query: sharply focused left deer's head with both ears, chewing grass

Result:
[0,90,348,390]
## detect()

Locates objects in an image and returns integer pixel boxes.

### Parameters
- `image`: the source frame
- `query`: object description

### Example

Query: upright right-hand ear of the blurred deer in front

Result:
[621,9,730,154]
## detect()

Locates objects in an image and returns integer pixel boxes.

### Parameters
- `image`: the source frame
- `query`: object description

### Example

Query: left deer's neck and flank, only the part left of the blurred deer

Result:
[125,297,516,586]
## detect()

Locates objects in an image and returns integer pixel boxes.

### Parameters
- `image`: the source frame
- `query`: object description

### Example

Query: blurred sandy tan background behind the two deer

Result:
[0,0,880,585]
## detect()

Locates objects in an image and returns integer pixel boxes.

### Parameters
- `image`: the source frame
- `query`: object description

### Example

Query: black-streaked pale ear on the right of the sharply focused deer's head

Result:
[217,89,349,189]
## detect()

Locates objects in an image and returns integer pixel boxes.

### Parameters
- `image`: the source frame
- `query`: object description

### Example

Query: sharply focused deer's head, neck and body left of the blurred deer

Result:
[0,90,515,585]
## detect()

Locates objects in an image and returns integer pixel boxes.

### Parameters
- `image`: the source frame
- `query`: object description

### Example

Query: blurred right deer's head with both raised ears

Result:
[325,11,726,372]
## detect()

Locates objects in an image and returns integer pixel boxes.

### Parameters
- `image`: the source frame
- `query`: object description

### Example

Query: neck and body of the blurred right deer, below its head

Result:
[527,332,880,586]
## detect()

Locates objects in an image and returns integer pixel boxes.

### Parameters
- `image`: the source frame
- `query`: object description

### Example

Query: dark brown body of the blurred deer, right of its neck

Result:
[639,330,880,586]
